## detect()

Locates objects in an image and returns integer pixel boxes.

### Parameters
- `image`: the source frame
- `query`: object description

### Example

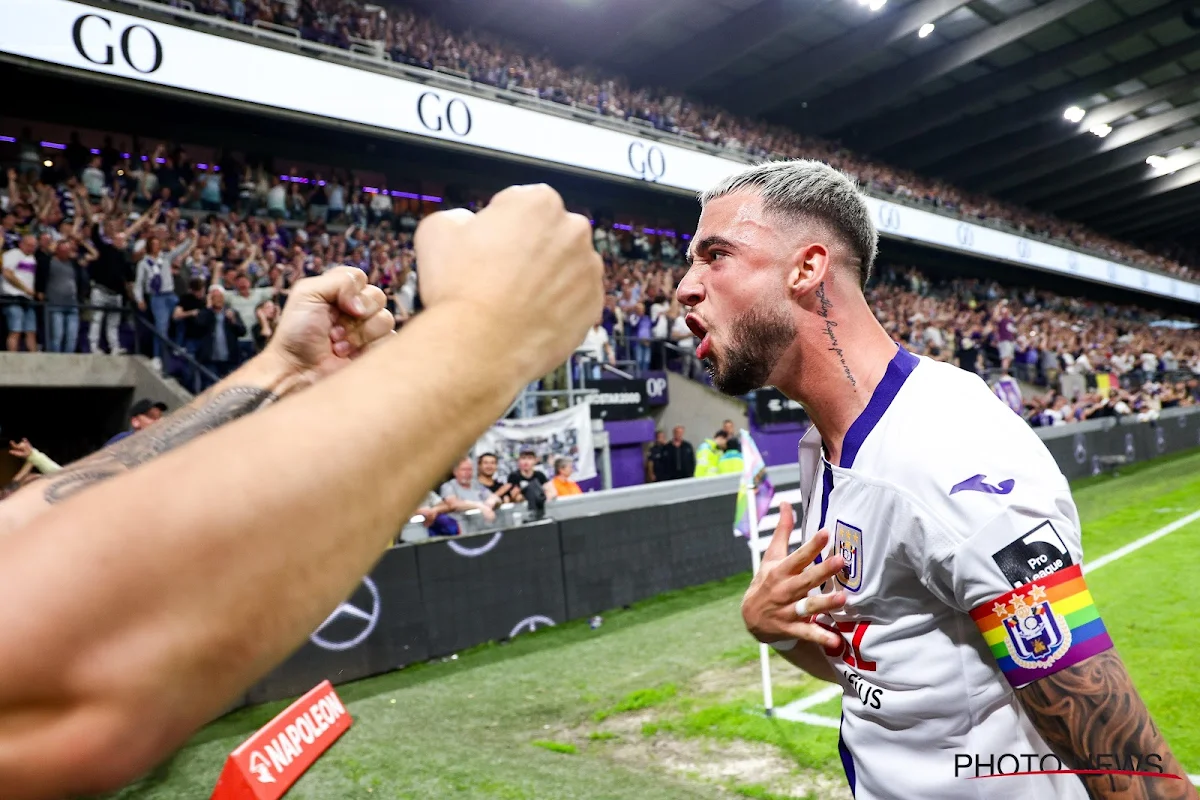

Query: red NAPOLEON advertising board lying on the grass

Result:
[211,680,350,800]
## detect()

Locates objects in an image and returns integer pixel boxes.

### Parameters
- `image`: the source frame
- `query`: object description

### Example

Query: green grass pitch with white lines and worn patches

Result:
[103,451,1200,800]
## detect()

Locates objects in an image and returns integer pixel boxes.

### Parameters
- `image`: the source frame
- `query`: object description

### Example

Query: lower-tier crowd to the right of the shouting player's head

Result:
[868,266,1200,426]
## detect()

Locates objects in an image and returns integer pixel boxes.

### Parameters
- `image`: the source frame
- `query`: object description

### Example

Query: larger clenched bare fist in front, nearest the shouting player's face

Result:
[415,185,604,380]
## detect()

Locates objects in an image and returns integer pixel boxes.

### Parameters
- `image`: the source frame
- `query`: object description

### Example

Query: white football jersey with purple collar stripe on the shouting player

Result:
[799,349,1112,800]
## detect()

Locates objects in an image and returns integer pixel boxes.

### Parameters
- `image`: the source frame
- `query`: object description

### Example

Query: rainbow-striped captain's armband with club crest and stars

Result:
[971,564,1112,688]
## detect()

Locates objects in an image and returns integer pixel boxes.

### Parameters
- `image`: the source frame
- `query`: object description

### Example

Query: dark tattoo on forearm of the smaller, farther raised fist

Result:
[46,386,277,504]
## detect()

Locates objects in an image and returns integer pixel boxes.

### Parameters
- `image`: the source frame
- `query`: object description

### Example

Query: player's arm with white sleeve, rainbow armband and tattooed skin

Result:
[922,470,1196,800]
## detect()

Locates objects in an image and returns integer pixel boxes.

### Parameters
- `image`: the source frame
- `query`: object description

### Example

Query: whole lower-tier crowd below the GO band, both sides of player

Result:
[0,132,1200,422]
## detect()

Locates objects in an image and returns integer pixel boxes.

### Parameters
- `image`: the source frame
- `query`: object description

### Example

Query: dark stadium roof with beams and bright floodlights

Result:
[416,0,1200,245]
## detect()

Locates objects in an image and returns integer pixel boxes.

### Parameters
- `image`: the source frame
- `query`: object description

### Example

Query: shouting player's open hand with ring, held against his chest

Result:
[742,503,846,648]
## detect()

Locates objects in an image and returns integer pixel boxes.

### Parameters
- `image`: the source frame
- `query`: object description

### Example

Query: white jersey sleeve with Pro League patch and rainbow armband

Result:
[897,367,1112,687]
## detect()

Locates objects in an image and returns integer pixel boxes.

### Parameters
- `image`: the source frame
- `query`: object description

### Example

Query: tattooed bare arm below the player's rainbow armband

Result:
[1016,650,1196,800]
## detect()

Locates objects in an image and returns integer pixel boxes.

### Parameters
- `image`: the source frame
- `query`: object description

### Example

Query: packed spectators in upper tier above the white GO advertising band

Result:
[152,0,1195,278]
